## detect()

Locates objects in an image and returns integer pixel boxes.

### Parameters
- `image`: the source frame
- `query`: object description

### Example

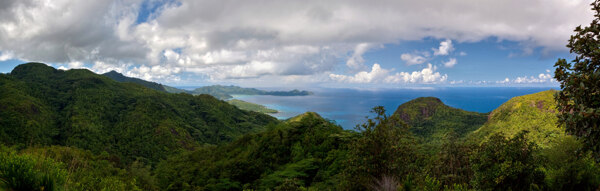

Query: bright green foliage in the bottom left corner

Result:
[0,146,66,190]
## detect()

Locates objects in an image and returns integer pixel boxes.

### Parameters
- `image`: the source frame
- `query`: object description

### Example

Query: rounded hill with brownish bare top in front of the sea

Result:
[394,97,487,138]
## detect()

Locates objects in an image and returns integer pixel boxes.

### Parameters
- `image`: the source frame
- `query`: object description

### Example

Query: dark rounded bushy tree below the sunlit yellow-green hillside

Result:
[471,131,544,190]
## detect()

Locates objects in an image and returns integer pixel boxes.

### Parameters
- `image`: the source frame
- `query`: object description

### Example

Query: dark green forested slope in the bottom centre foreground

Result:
[156,112,351,190]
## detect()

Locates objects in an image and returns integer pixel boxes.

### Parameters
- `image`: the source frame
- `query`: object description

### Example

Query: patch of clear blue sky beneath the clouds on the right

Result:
[364,38,573,81]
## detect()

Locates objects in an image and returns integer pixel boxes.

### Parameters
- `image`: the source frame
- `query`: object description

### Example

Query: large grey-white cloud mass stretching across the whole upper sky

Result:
[0,0,593,83]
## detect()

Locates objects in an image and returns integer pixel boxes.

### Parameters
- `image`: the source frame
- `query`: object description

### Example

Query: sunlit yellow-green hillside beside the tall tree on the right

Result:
[472,90,566,147]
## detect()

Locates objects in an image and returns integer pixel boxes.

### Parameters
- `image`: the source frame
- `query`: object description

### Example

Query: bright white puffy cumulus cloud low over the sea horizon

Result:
[329,64,448,84]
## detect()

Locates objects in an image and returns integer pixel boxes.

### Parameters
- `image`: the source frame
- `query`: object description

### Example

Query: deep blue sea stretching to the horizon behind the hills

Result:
[229,87,556,129]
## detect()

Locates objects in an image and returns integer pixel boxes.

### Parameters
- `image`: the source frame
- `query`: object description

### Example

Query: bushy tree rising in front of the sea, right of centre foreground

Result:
[345,106,417,189]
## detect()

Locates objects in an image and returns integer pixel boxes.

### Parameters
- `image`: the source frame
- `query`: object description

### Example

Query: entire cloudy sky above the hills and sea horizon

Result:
[0,0,593,88]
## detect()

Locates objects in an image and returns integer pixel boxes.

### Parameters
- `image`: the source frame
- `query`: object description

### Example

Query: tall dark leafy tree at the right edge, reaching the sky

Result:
[554,0,600,154]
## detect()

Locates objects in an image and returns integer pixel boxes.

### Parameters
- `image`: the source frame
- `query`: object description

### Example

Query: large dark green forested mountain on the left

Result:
[0,63,277,163]
